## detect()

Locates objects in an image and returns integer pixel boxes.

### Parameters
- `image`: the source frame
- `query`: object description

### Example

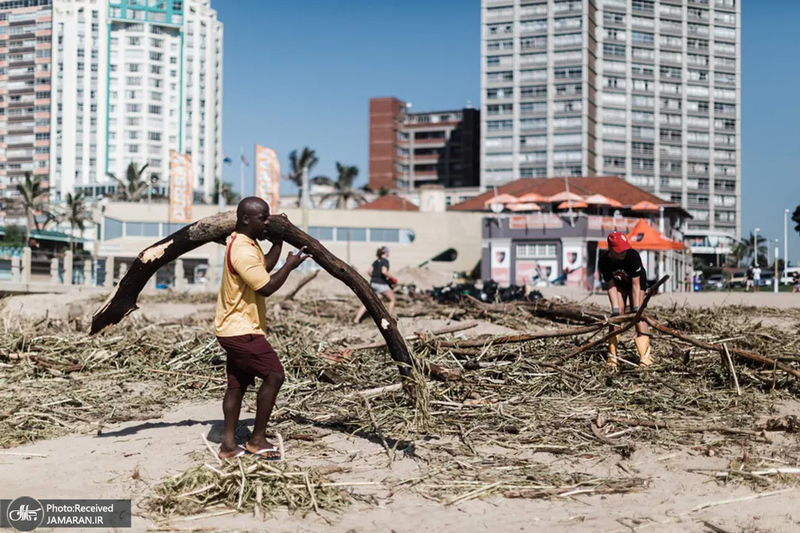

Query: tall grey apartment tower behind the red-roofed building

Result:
[481,0,741,235]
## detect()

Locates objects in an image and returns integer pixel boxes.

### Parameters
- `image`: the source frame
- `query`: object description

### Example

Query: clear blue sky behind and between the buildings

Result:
[212,0,800,263]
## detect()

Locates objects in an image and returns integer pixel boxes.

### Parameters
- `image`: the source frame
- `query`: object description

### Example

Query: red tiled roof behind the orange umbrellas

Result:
[450,176,680,211]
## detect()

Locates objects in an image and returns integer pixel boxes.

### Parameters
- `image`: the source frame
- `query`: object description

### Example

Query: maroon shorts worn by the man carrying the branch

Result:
[217,335,283,389]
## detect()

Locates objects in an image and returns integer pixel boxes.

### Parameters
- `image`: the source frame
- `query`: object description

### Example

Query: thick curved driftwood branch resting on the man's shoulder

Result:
[91,211,455,379]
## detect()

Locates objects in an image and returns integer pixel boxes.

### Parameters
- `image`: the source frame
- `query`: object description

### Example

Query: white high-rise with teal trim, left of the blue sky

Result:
[43,0,223,201]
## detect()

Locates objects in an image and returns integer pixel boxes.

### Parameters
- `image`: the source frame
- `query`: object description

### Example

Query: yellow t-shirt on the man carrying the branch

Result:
[214,232,270,337]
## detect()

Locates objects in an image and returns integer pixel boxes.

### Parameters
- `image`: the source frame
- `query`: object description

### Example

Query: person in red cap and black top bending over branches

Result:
[598,231,653,371]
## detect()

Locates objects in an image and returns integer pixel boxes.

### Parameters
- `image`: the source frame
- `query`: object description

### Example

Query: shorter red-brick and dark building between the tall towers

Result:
[369,98,480,191]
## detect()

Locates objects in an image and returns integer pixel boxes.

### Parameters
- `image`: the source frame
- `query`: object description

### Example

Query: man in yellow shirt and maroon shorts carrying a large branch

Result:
[214,197,309,459]
